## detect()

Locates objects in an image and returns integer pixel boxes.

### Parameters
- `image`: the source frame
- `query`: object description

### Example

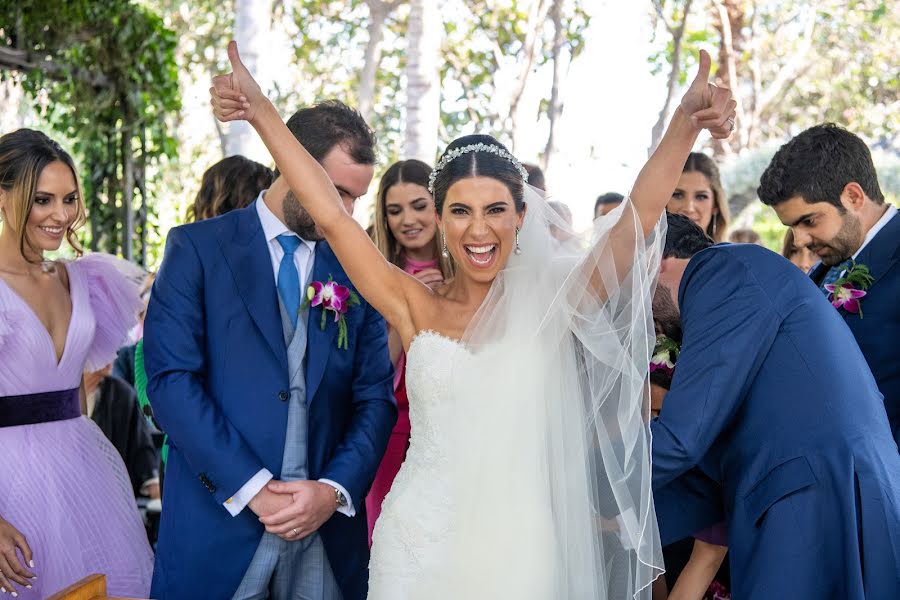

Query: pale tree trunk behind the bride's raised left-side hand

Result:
[225,0,272,156]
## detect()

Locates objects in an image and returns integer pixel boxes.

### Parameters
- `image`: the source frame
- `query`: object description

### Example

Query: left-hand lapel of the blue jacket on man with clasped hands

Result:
[217,203,287,370]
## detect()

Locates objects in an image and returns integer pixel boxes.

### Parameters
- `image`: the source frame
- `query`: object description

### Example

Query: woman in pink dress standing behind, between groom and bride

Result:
[366,160,453,546]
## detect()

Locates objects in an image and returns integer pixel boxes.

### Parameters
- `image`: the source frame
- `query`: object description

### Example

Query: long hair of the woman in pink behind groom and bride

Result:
[373,159,455,280]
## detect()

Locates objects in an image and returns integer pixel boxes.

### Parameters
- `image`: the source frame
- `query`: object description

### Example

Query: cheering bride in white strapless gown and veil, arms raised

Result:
[210,42,735,600]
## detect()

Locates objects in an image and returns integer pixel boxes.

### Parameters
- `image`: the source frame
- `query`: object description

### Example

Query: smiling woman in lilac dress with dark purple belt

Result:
[0,129,153,599]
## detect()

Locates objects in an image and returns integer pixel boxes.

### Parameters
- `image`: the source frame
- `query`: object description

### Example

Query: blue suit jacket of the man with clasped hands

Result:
[144,205,397,600]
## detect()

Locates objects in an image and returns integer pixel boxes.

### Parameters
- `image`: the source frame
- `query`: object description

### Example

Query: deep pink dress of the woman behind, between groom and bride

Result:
[366,258,438,546]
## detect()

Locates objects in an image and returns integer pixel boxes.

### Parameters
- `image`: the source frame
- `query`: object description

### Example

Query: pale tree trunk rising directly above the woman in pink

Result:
[403,0,443,164]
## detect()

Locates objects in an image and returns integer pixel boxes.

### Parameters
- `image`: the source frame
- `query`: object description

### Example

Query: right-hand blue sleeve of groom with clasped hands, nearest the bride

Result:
[319,304,397,508]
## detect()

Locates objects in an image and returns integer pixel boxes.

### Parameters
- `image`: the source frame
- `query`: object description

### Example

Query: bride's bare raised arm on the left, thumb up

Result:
[209,42,422,336]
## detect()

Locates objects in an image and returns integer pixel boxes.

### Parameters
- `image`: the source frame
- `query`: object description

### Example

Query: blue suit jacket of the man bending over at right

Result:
[651,244,900,600]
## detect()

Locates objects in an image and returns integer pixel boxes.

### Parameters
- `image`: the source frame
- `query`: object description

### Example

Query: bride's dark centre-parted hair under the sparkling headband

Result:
[434,135,525,214]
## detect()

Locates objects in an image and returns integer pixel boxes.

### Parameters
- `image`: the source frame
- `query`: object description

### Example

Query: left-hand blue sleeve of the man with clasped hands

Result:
[144,228,264,510]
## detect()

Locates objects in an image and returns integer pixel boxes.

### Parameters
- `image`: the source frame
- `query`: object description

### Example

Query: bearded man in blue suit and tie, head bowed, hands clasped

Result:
[144,101,396,600]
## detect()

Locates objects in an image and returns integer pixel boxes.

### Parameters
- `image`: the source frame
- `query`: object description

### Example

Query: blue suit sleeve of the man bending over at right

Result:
[651,248,782,489]
